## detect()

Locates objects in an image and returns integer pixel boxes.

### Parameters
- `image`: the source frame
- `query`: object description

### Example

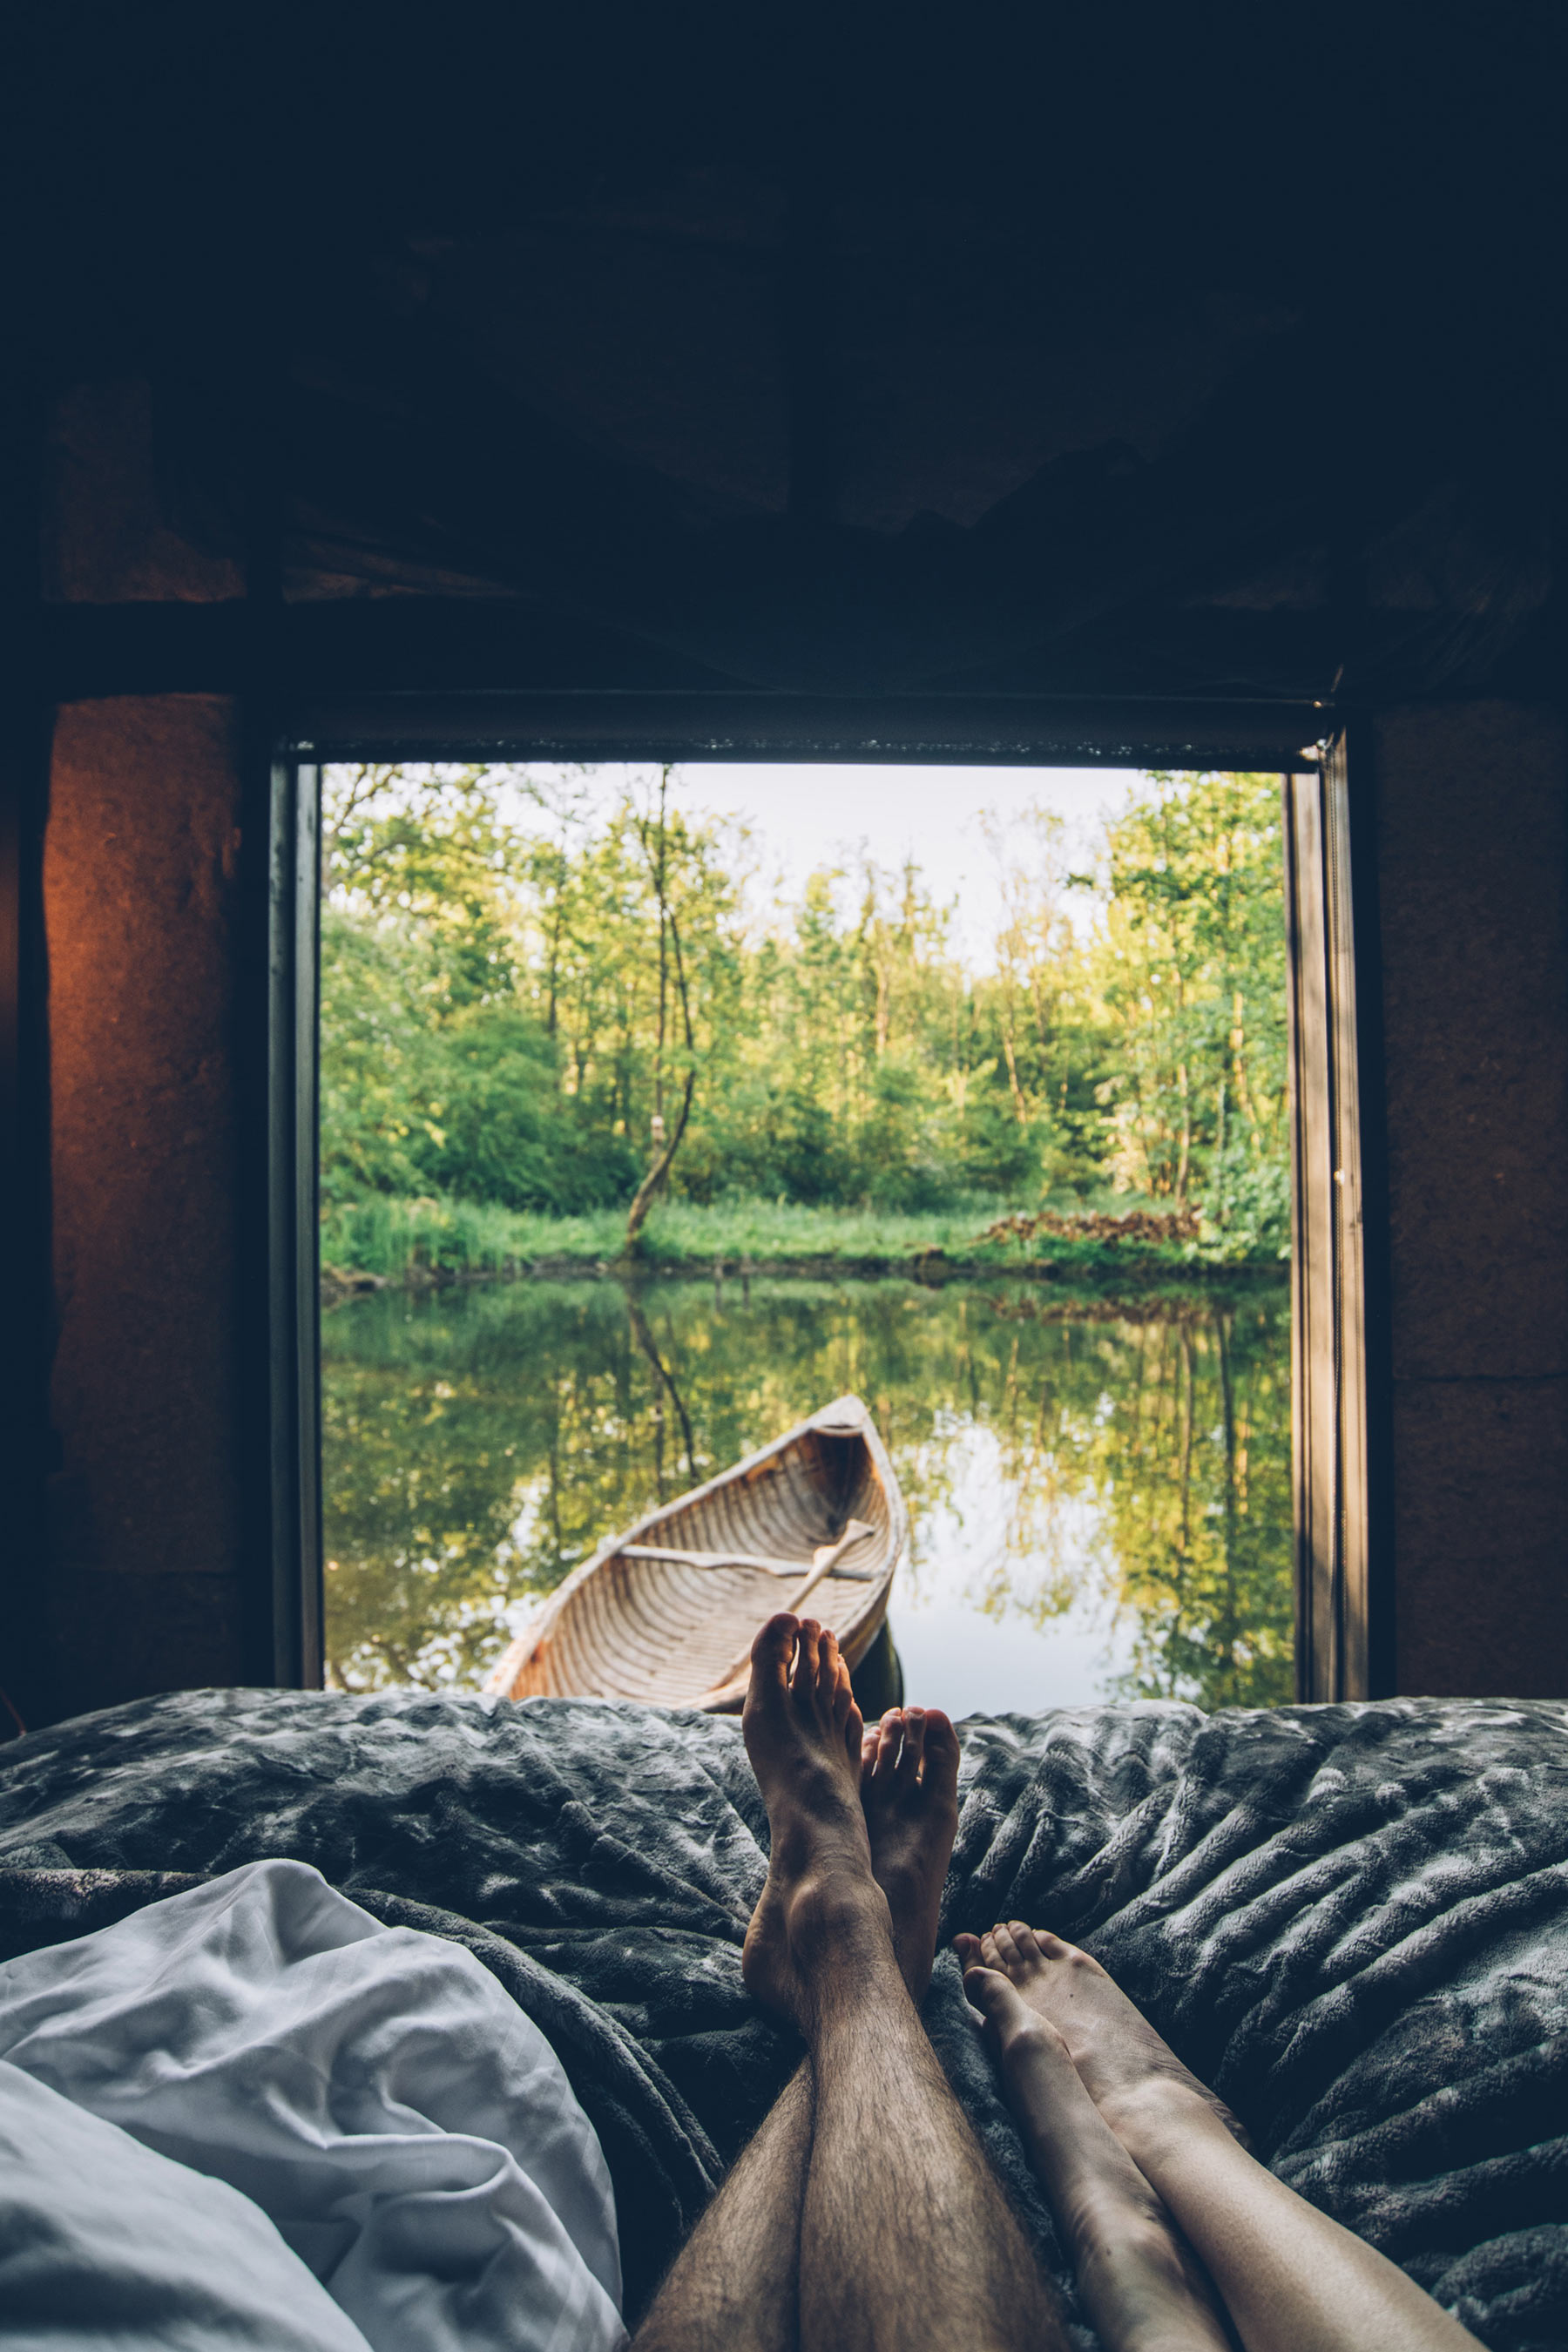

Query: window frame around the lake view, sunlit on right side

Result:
[268,692,1392,1700]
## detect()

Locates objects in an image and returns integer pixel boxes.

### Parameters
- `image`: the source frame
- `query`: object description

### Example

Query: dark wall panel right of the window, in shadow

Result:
[1370,701,1568,1698]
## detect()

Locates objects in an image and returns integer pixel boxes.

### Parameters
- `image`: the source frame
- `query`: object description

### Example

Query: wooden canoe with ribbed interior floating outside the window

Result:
[487,1397,909,1714]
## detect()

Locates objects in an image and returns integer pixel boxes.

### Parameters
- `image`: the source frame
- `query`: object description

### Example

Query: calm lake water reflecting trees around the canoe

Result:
[322,1280,1293,1714]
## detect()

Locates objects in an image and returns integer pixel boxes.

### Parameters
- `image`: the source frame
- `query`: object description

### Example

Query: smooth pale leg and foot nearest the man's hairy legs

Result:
[963,1936,1229,2352]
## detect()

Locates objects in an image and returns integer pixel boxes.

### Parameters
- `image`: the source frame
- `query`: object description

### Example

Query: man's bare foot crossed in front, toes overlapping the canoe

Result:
[740,1613,891,2027]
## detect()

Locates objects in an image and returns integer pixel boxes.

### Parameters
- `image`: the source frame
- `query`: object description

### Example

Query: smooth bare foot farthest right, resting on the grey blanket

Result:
[955,1919,1248,2154]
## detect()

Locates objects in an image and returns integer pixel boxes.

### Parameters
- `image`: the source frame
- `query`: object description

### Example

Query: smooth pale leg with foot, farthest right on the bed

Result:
[959,1919,1477,2352]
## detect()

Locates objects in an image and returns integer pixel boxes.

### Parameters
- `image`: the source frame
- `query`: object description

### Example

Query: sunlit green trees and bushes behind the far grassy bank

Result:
[322,767,1288,1256]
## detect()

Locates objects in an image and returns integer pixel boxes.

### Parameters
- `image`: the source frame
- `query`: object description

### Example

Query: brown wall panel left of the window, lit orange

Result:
[44,696,245,1713]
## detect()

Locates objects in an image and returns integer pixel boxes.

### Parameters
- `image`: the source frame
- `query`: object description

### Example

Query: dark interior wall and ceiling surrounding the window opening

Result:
[0,0,1568,1734]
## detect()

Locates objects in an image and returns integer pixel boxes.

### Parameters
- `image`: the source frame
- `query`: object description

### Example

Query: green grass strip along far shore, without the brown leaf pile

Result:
[322,1193,1279,1282]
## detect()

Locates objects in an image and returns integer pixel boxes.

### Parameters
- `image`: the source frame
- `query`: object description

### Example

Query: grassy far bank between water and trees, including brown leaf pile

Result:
[322,1193,1281,1287]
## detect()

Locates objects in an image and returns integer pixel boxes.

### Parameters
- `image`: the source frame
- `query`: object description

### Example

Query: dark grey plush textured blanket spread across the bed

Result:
[0,1691,1568,2352]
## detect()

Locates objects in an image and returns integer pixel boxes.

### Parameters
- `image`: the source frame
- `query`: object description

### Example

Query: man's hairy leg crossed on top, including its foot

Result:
[745,1616,1064,2352]
